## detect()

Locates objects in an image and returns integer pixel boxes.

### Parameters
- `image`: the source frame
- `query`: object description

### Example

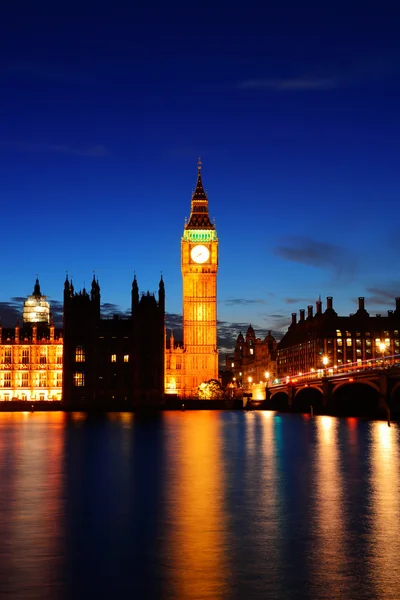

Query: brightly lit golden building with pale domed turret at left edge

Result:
[0,279,63,402]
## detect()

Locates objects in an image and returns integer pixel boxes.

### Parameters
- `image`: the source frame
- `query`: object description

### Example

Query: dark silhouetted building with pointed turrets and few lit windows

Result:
[63,277,165,409]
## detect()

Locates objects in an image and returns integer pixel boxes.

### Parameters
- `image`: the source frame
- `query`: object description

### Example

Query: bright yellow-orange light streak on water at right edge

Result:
[370,421,400,600]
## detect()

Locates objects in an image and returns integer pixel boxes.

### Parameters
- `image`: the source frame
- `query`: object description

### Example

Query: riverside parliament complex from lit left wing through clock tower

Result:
[0,160,218,409]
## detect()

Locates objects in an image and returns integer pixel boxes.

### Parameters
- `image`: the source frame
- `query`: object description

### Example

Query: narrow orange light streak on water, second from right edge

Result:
[312,416,346,599]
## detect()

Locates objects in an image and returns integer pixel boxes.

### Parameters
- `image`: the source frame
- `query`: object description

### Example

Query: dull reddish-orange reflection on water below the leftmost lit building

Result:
[0,412,65,599]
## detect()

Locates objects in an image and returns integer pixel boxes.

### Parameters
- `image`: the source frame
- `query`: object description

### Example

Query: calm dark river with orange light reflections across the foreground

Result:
[0,411,400,600]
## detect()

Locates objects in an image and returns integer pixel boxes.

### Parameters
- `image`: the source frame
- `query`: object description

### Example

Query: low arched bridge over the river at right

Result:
[262,363,400,416]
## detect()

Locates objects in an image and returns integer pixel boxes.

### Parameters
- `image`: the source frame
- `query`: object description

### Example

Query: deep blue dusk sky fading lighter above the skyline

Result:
[0,0,400,347]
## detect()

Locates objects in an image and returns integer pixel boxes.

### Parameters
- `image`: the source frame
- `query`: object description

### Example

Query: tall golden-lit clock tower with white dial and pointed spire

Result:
[181,159,218,396]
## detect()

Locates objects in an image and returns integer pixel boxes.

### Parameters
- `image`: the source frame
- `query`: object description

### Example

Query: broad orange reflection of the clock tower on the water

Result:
[164,411,229,600]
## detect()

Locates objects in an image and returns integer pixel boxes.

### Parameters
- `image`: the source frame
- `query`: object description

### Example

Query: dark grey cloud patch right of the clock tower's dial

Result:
[274,237,355,277]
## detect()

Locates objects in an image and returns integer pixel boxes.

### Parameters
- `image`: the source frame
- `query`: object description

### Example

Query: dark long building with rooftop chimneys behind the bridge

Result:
[278,296,400,377]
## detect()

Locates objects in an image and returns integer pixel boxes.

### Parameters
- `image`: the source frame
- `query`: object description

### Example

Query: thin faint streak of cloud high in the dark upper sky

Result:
[237,77,340,92]
